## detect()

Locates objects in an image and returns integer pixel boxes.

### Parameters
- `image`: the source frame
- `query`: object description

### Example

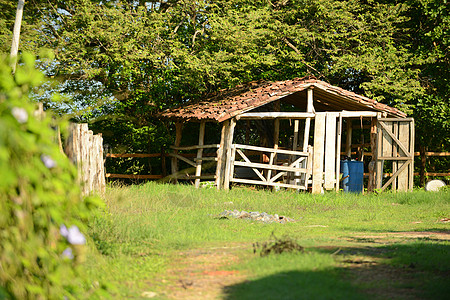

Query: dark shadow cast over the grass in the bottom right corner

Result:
[224,241,450,300]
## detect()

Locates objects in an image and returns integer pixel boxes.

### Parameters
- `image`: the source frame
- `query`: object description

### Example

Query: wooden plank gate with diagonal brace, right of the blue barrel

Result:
[376,118,414,191]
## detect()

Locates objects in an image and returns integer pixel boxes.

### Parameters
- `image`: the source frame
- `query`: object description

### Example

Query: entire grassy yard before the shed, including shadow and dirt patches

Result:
[87,183,450,299]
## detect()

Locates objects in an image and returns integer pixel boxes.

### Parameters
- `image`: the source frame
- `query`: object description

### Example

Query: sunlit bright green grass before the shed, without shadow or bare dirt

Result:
[85,183,450,299]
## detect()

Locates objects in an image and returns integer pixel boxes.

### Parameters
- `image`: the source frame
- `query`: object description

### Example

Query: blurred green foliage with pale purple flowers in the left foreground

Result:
[0,54,106,299]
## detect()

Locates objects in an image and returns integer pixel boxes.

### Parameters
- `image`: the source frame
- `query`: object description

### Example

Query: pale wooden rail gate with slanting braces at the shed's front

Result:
[229,144,312,190]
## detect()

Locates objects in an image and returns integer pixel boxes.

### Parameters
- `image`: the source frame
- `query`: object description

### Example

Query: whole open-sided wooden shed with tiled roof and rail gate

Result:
[159,77,414,193]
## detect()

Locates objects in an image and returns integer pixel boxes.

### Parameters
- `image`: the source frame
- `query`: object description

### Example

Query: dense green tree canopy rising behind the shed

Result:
[0,0,450,162]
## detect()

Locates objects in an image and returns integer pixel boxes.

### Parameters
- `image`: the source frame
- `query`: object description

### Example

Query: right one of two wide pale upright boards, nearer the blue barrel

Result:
[324,112,338,190]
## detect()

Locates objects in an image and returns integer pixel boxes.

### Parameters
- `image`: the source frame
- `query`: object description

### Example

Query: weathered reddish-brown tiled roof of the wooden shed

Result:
[157,78,406,122]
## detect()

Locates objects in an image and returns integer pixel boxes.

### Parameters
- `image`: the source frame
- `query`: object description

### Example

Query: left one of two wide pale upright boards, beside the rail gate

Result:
[312,113,326,194]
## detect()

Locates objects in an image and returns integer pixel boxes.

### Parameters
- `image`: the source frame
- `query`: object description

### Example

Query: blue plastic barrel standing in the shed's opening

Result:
[341,160,364,193]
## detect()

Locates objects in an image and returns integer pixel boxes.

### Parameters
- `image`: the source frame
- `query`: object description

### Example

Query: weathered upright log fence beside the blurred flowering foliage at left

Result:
[65,124,105,195]
